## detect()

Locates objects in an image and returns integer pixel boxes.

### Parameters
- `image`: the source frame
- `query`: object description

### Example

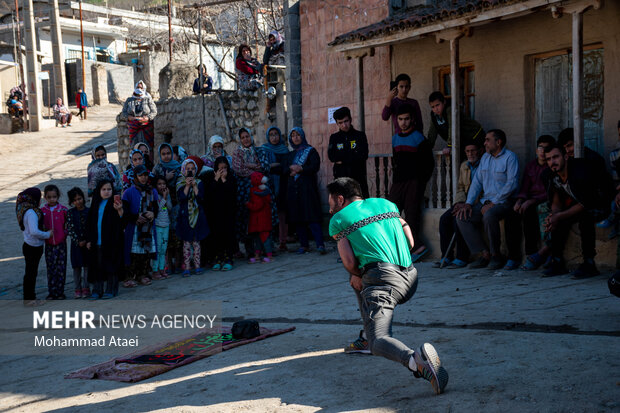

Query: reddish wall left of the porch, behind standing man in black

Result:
[300,0,391,208]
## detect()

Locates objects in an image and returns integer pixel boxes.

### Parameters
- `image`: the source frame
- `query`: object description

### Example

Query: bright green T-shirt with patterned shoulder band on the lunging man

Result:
[329,198,411,267]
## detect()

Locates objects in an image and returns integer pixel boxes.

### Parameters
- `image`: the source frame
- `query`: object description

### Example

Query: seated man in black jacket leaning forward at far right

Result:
[542,145,615,279]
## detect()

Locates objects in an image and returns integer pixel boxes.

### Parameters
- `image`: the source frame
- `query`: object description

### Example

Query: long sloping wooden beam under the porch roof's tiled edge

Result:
[328,0,568,52]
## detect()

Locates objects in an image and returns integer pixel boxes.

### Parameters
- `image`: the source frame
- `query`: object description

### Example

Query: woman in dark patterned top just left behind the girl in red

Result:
[232,128,269,254]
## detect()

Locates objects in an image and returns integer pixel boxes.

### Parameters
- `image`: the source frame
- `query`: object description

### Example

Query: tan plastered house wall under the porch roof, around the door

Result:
[392,2,620,166]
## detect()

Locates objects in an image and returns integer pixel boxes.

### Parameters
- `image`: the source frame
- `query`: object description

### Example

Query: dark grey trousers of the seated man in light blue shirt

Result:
[456,202,521,255]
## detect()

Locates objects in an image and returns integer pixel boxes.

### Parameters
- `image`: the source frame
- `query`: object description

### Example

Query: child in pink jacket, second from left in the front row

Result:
[41,185,68,300]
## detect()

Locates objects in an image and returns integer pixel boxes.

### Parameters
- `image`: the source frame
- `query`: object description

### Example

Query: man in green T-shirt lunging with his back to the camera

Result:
[327,178,448,394]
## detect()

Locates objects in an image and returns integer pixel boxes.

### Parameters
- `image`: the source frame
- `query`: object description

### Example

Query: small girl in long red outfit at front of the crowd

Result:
[246,172,273,264]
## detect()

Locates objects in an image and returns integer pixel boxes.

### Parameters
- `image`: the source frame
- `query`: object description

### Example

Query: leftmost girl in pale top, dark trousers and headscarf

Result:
[15,188,52,307]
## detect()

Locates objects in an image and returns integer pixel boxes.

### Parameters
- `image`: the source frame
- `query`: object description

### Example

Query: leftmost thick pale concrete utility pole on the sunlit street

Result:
[24,0,43,132]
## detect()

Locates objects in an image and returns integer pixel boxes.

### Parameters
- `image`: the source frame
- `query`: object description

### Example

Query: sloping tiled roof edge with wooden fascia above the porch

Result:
[328,0,602,56]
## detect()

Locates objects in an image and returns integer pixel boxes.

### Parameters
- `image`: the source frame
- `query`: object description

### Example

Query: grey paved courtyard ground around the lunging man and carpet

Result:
[0,107,620,412]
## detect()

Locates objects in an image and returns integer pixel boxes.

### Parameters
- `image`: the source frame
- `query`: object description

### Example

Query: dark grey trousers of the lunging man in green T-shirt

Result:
[355,263,418,367]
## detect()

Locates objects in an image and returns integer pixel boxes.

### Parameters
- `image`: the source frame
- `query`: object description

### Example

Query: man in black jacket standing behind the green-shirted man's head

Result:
[327,106,368,198]
